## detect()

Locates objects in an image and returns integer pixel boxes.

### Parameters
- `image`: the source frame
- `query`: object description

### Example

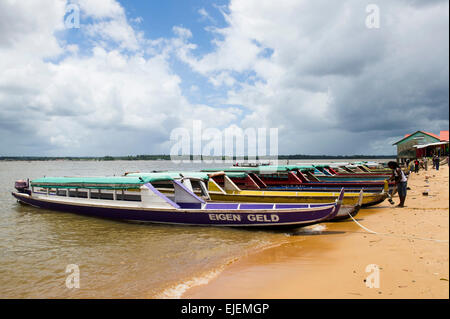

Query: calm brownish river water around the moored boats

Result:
[0,160,390,298]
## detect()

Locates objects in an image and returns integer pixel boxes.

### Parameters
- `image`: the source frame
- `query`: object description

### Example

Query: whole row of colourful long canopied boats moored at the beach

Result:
[12,162,393,228]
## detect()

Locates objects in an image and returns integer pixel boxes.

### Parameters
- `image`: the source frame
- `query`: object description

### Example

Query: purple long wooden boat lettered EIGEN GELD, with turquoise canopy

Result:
[12,176,344,228]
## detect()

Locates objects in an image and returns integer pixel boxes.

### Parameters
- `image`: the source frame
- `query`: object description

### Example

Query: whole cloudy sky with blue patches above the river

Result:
[0,0,449,156]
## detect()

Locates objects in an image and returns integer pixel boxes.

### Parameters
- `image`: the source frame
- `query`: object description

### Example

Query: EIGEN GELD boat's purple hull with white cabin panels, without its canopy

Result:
[12,180,344,227]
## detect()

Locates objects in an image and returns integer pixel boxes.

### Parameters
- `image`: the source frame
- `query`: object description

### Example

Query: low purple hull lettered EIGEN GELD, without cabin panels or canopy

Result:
[12,192,340,227]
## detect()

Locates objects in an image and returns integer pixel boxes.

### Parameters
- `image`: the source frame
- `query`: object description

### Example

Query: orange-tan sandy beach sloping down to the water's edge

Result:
[182,165,449,299]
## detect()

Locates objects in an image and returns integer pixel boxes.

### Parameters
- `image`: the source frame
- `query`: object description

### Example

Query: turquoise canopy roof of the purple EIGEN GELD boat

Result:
[30,173,172,189]
